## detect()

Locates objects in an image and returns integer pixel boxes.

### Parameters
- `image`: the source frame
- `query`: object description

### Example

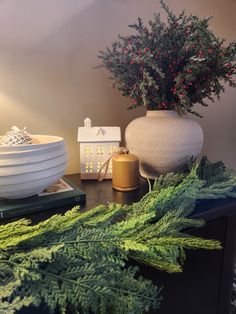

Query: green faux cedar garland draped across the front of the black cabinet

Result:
[0,158,236,314]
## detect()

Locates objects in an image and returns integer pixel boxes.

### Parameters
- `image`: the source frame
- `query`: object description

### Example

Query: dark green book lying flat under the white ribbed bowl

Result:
[0,177,86,219]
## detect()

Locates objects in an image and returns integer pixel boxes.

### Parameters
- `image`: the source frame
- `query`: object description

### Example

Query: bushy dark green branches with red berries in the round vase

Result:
[98,1,236,115]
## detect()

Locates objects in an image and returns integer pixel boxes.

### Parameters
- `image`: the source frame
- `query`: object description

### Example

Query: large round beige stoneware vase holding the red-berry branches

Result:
[125,110,203,179]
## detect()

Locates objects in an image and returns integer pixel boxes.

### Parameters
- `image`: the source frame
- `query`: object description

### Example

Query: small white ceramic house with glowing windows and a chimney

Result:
[78,118,121,179]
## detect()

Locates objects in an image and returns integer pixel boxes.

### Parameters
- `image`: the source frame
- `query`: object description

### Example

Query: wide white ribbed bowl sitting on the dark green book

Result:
[0,135,67,199]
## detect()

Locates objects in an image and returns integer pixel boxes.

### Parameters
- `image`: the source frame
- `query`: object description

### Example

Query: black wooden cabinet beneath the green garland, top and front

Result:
[8,174,236,314]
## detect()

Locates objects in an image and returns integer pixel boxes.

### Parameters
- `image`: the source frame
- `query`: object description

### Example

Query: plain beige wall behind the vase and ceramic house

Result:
[0,0,236,173]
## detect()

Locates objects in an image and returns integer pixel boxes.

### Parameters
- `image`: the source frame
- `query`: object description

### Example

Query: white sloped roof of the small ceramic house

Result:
[78,126,121,142]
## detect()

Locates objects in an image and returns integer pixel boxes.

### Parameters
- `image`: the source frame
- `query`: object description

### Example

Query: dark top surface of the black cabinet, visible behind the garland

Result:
[1,174,236,223]
